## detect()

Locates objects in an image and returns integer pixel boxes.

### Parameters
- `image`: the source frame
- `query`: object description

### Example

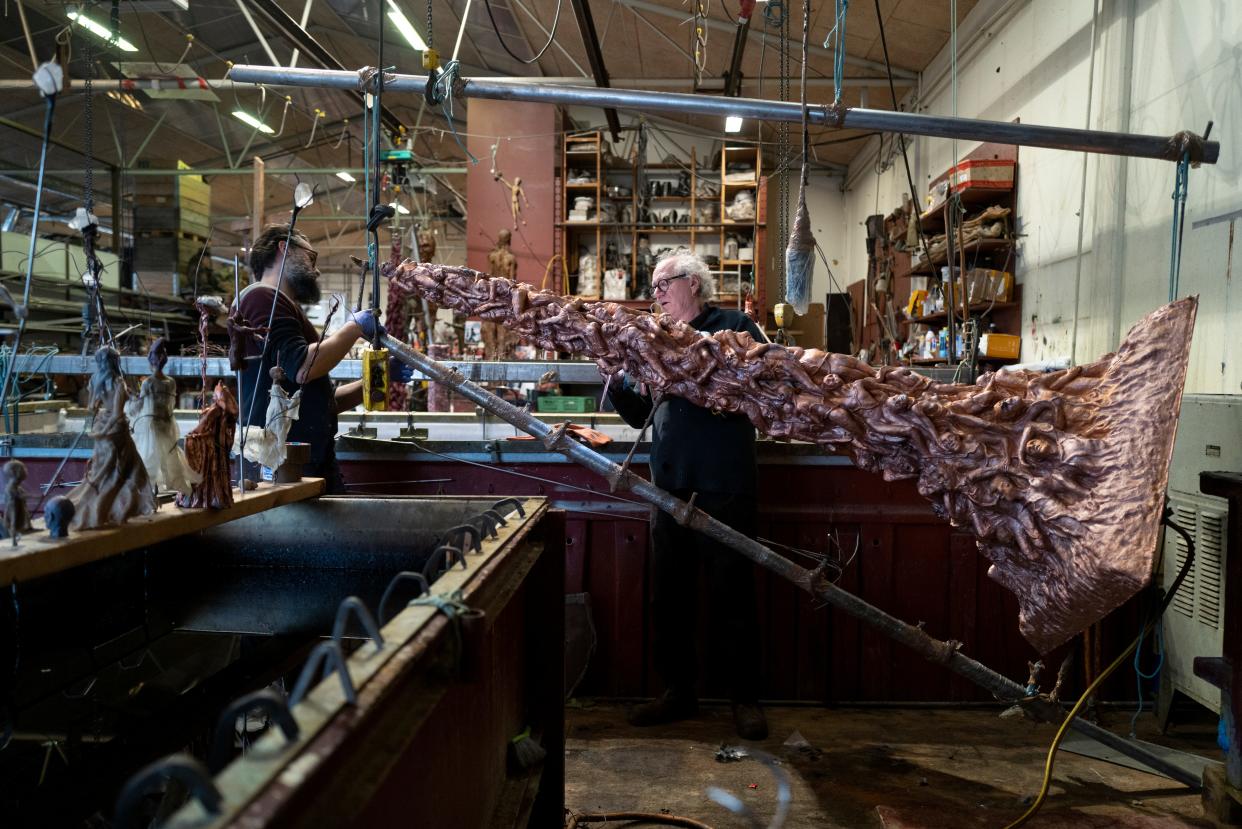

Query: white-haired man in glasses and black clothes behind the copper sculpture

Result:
[610,250,768,740]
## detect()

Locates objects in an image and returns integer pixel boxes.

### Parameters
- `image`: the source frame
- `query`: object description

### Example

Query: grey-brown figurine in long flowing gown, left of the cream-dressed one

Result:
[68,346,155,529]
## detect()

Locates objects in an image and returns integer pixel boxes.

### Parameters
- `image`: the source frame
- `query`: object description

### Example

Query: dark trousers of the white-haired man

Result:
[651,490,760,702]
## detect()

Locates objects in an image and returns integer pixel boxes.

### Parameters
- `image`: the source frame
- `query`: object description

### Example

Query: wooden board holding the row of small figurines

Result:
[0,477,323,584]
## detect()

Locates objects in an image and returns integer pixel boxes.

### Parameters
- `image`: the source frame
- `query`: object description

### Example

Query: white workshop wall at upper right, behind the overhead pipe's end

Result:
[841,0,1242,393]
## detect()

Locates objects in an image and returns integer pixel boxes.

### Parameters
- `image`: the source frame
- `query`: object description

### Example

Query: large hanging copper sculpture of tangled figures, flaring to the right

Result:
[385,261,1197,651]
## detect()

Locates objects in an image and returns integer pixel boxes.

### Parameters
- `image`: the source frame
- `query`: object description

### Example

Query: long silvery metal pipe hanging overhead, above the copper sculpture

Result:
[229,65,1221,164]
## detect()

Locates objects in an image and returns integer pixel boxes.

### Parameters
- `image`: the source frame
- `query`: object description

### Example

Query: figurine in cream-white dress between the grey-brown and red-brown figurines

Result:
[125,337,199,492]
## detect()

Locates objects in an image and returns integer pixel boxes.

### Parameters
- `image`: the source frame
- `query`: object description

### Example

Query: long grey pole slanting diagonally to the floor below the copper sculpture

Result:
[384,334,1200,788]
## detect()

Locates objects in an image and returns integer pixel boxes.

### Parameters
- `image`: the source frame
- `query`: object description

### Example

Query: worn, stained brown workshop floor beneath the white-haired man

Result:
[565,703,1220,829]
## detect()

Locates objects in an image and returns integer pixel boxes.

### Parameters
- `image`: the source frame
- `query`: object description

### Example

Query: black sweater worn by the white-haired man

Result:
[609,307,764,495]
